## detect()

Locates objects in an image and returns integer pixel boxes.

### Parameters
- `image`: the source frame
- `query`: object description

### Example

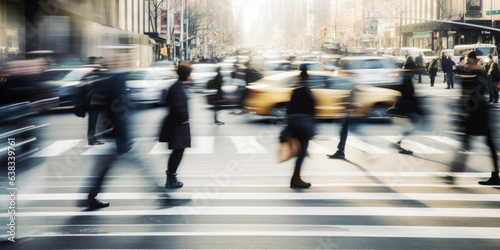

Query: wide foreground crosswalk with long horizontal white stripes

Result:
[0,168,500,249]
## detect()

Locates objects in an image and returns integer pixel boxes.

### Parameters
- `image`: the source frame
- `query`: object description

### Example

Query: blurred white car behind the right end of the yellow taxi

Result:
[336,56,401,88]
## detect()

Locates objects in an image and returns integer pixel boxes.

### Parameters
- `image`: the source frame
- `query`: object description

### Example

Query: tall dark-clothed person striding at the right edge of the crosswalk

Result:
[445,51,500,185]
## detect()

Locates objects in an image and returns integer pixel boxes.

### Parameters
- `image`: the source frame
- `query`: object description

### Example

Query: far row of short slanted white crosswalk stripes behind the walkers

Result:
[24,135,496,158]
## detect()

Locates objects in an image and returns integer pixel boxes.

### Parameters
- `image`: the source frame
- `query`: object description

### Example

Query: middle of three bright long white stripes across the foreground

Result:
[5,206,500,218]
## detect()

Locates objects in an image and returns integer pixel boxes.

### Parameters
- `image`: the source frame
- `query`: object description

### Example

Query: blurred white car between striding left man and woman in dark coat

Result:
[125,68,177,105]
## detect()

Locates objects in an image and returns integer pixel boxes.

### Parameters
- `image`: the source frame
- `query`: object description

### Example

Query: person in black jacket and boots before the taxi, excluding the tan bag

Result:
[287,65,316,188]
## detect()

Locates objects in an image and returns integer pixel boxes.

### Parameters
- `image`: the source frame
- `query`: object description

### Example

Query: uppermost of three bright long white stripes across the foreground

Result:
[10,192,500,202]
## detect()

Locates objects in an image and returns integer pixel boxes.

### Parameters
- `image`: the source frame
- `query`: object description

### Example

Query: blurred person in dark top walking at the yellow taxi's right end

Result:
[388,69,424,154]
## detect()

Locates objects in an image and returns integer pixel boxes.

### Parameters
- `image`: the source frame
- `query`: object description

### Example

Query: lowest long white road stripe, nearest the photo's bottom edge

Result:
[30,224,500,239]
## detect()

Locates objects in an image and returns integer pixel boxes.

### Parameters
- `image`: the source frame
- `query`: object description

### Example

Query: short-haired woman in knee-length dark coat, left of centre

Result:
[160,63,192,188]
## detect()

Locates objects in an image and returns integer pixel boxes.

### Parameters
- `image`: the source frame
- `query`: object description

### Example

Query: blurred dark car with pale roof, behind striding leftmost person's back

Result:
[40,67,97,107]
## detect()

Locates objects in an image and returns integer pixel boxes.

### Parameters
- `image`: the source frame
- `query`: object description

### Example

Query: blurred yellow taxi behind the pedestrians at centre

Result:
[245,70,400,121]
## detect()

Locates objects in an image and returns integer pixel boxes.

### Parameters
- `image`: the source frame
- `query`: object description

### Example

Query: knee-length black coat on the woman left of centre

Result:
[159,80,191,149]
